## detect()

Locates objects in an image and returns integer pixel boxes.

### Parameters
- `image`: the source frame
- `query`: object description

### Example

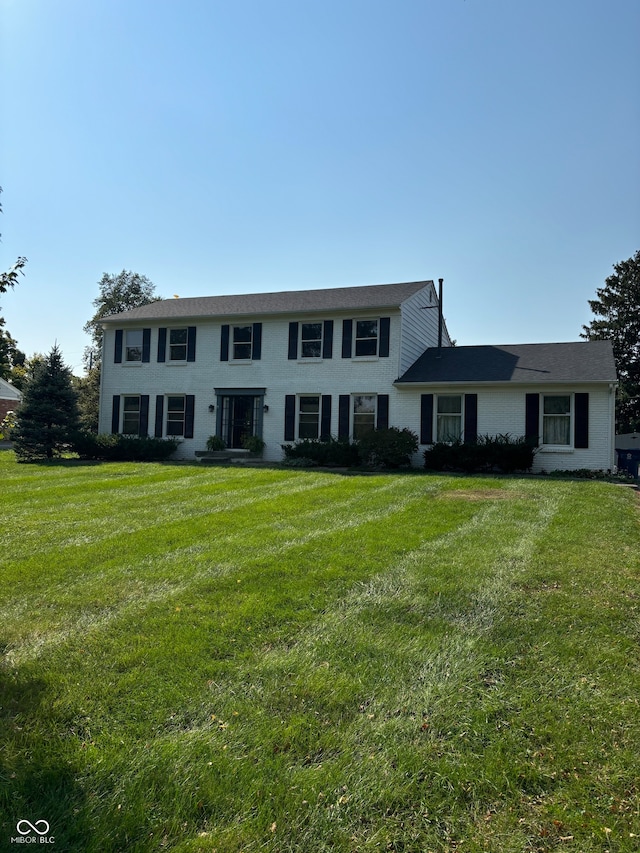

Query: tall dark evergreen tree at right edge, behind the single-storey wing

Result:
[581,251,640,433]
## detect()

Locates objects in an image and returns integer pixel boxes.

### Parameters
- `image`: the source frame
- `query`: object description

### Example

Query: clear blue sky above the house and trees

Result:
[0,0,640,374]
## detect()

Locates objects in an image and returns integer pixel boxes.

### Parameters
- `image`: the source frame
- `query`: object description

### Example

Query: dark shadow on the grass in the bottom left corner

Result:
[0,660,91,851]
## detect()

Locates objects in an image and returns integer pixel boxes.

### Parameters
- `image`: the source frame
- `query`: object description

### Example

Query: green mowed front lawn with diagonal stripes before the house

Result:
[0,451,640,853]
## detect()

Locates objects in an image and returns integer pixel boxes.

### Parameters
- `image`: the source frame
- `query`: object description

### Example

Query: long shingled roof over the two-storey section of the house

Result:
[103,281,433,324]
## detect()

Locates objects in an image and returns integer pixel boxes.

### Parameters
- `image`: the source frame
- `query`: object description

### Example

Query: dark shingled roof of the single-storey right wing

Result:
[397,341,617,384]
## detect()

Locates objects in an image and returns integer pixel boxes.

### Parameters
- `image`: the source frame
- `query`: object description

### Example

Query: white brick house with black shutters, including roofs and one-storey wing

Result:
[100,281,616,470]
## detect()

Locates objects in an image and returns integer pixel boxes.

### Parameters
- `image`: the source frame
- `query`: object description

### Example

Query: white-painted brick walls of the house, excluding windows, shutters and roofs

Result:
[100,310,614,471]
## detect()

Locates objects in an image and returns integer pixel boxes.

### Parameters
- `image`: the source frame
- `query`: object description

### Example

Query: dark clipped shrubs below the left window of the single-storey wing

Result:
[424,433,536,474]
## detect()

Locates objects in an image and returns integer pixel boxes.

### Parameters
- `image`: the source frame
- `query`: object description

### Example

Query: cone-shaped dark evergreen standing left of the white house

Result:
[12,344,78,461]
